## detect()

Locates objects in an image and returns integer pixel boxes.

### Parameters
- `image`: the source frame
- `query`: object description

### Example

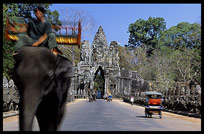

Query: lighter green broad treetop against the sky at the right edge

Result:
[159,22,201,49]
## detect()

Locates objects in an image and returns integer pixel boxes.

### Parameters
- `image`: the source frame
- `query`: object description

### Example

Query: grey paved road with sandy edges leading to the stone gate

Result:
[3,99,201,131]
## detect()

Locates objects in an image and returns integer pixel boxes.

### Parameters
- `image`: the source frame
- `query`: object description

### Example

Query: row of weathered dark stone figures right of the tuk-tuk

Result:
[163,83,201,114]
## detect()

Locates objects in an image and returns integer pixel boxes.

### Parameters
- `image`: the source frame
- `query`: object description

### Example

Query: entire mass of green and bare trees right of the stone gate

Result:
[124,17,201,86]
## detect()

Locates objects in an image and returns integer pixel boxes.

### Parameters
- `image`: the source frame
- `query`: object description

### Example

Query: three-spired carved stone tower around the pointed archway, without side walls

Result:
[78,26,120,94]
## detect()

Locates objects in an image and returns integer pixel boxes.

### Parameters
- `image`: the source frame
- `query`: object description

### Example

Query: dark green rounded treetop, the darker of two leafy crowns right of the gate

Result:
[126,17,166,55]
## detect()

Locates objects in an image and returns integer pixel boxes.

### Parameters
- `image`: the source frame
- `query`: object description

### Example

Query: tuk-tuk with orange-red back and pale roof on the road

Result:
[145,91,163,119]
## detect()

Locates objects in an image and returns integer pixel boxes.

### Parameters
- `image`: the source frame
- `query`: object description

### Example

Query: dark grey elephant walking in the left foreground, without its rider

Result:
[14,47,73,131]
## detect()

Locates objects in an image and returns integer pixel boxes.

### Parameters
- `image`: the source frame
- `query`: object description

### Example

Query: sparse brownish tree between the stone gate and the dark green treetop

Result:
[118,44,155,81]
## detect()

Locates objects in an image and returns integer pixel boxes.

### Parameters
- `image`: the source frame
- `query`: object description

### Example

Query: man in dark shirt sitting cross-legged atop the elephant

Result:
[9,6,62,55]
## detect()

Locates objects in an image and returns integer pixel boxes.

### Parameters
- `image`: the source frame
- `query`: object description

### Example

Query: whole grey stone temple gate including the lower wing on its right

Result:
[72,26,143,96]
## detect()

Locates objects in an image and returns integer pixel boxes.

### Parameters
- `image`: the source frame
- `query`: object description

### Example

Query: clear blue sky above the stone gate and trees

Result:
[50,3,201,46]
